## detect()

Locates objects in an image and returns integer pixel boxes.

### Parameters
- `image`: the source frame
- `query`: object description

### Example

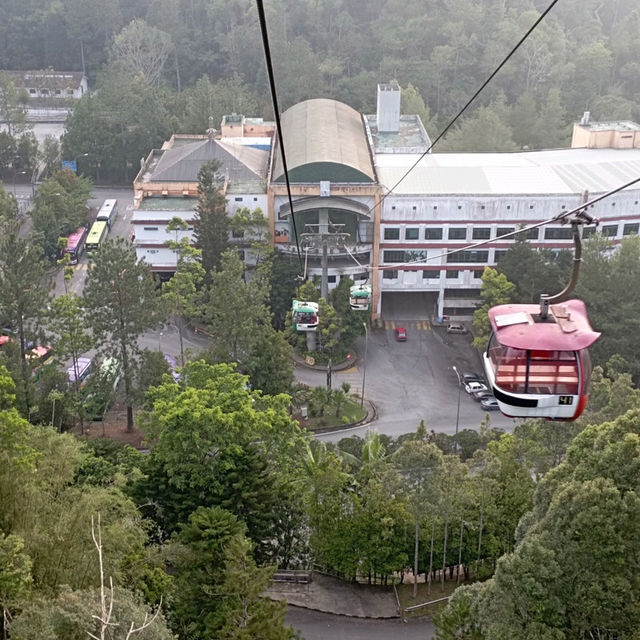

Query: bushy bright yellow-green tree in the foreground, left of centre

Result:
[136,362,301,557]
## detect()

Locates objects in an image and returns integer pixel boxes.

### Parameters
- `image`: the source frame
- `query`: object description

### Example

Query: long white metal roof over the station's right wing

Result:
[375,149,640,196]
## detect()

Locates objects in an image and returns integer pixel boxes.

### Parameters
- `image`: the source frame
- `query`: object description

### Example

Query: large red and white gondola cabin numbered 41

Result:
[484,300,600,420]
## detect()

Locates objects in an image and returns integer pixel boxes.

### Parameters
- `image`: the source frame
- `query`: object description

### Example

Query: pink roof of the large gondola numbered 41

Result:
[489,300,600,351]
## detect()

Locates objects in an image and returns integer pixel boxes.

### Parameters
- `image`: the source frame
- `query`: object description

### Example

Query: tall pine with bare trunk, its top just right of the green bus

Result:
[84,238,162,431]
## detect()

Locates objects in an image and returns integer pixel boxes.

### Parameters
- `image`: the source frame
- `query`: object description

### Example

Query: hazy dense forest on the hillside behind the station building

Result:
[0,0,640,151]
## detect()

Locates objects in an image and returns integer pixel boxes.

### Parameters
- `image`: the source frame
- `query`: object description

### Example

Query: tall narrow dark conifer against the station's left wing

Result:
[194,160,229,277]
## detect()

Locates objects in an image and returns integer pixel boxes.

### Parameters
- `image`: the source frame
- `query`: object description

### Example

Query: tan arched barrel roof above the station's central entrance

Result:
[272,98,375,182]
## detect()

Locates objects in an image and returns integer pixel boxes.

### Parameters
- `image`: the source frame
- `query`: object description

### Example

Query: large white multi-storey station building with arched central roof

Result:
[134,84,640,320]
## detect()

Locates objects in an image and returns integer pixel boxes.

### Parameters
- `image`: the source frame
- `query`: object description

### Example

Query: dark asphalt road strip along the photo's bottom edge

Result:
[287,607,435,640]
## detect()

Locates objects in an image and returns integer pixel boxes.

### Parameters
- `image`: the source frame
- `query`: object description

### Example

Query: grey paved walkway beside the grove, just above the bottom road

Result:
[265,573,398,618]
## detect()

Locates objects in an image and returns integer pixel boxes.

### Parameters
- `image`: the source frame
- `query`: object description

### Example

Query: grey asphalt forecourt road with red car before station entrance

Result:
[296,320,515,442]
